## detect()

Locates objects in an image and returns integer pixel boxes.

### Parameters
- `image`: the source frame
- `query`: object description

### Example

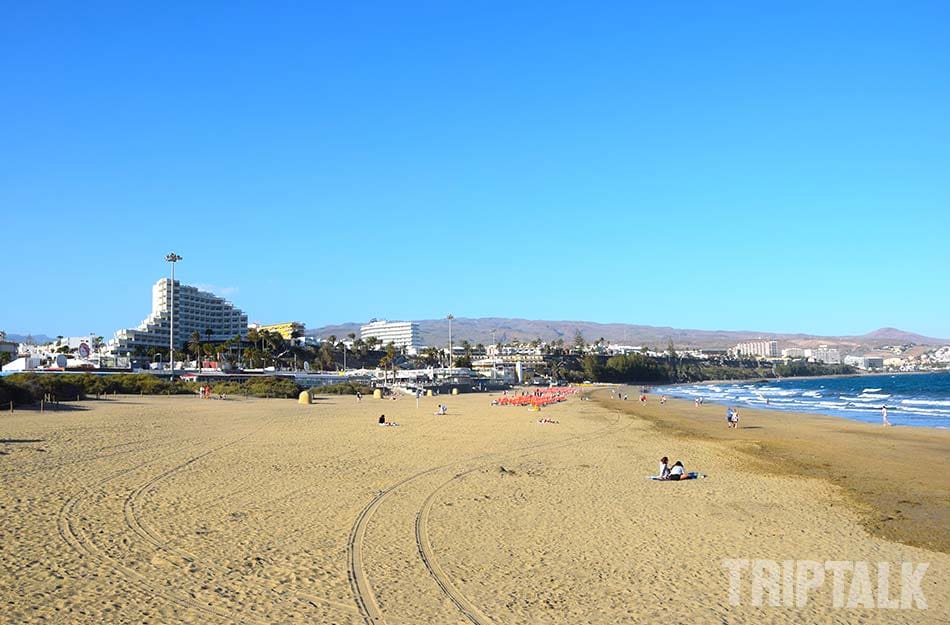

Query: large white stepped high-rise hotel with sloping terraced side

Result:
[106,278,247,354]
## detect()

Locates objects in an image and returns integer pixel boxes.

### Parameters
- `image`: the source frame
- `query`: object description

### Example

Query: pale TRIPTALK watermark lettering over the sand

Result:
[722,559,930,610]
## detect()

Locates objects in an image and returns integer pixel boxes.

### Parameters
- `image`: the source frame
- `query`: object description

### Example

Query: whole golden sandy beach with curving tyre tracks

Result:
[0,391,950,625]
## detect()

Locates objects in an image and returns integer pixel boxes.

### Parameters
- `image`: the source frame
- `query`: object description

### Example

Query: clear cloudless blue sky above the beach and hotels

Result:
[0,1,950,337]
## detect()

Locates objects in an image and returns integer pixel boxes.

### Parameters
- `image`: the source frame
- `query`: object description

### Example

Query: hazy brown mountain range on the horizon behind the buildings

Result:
[306,317,950,353]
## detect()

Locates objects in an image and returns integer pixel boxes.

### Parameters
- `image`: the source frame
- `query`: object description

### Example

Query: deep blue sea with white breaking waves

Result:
[653,372,950,428]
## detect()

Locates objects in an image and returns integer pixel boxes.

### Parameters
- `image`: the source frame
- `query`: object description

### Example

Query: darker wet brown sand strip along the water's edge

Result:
[591,390,950,553]
